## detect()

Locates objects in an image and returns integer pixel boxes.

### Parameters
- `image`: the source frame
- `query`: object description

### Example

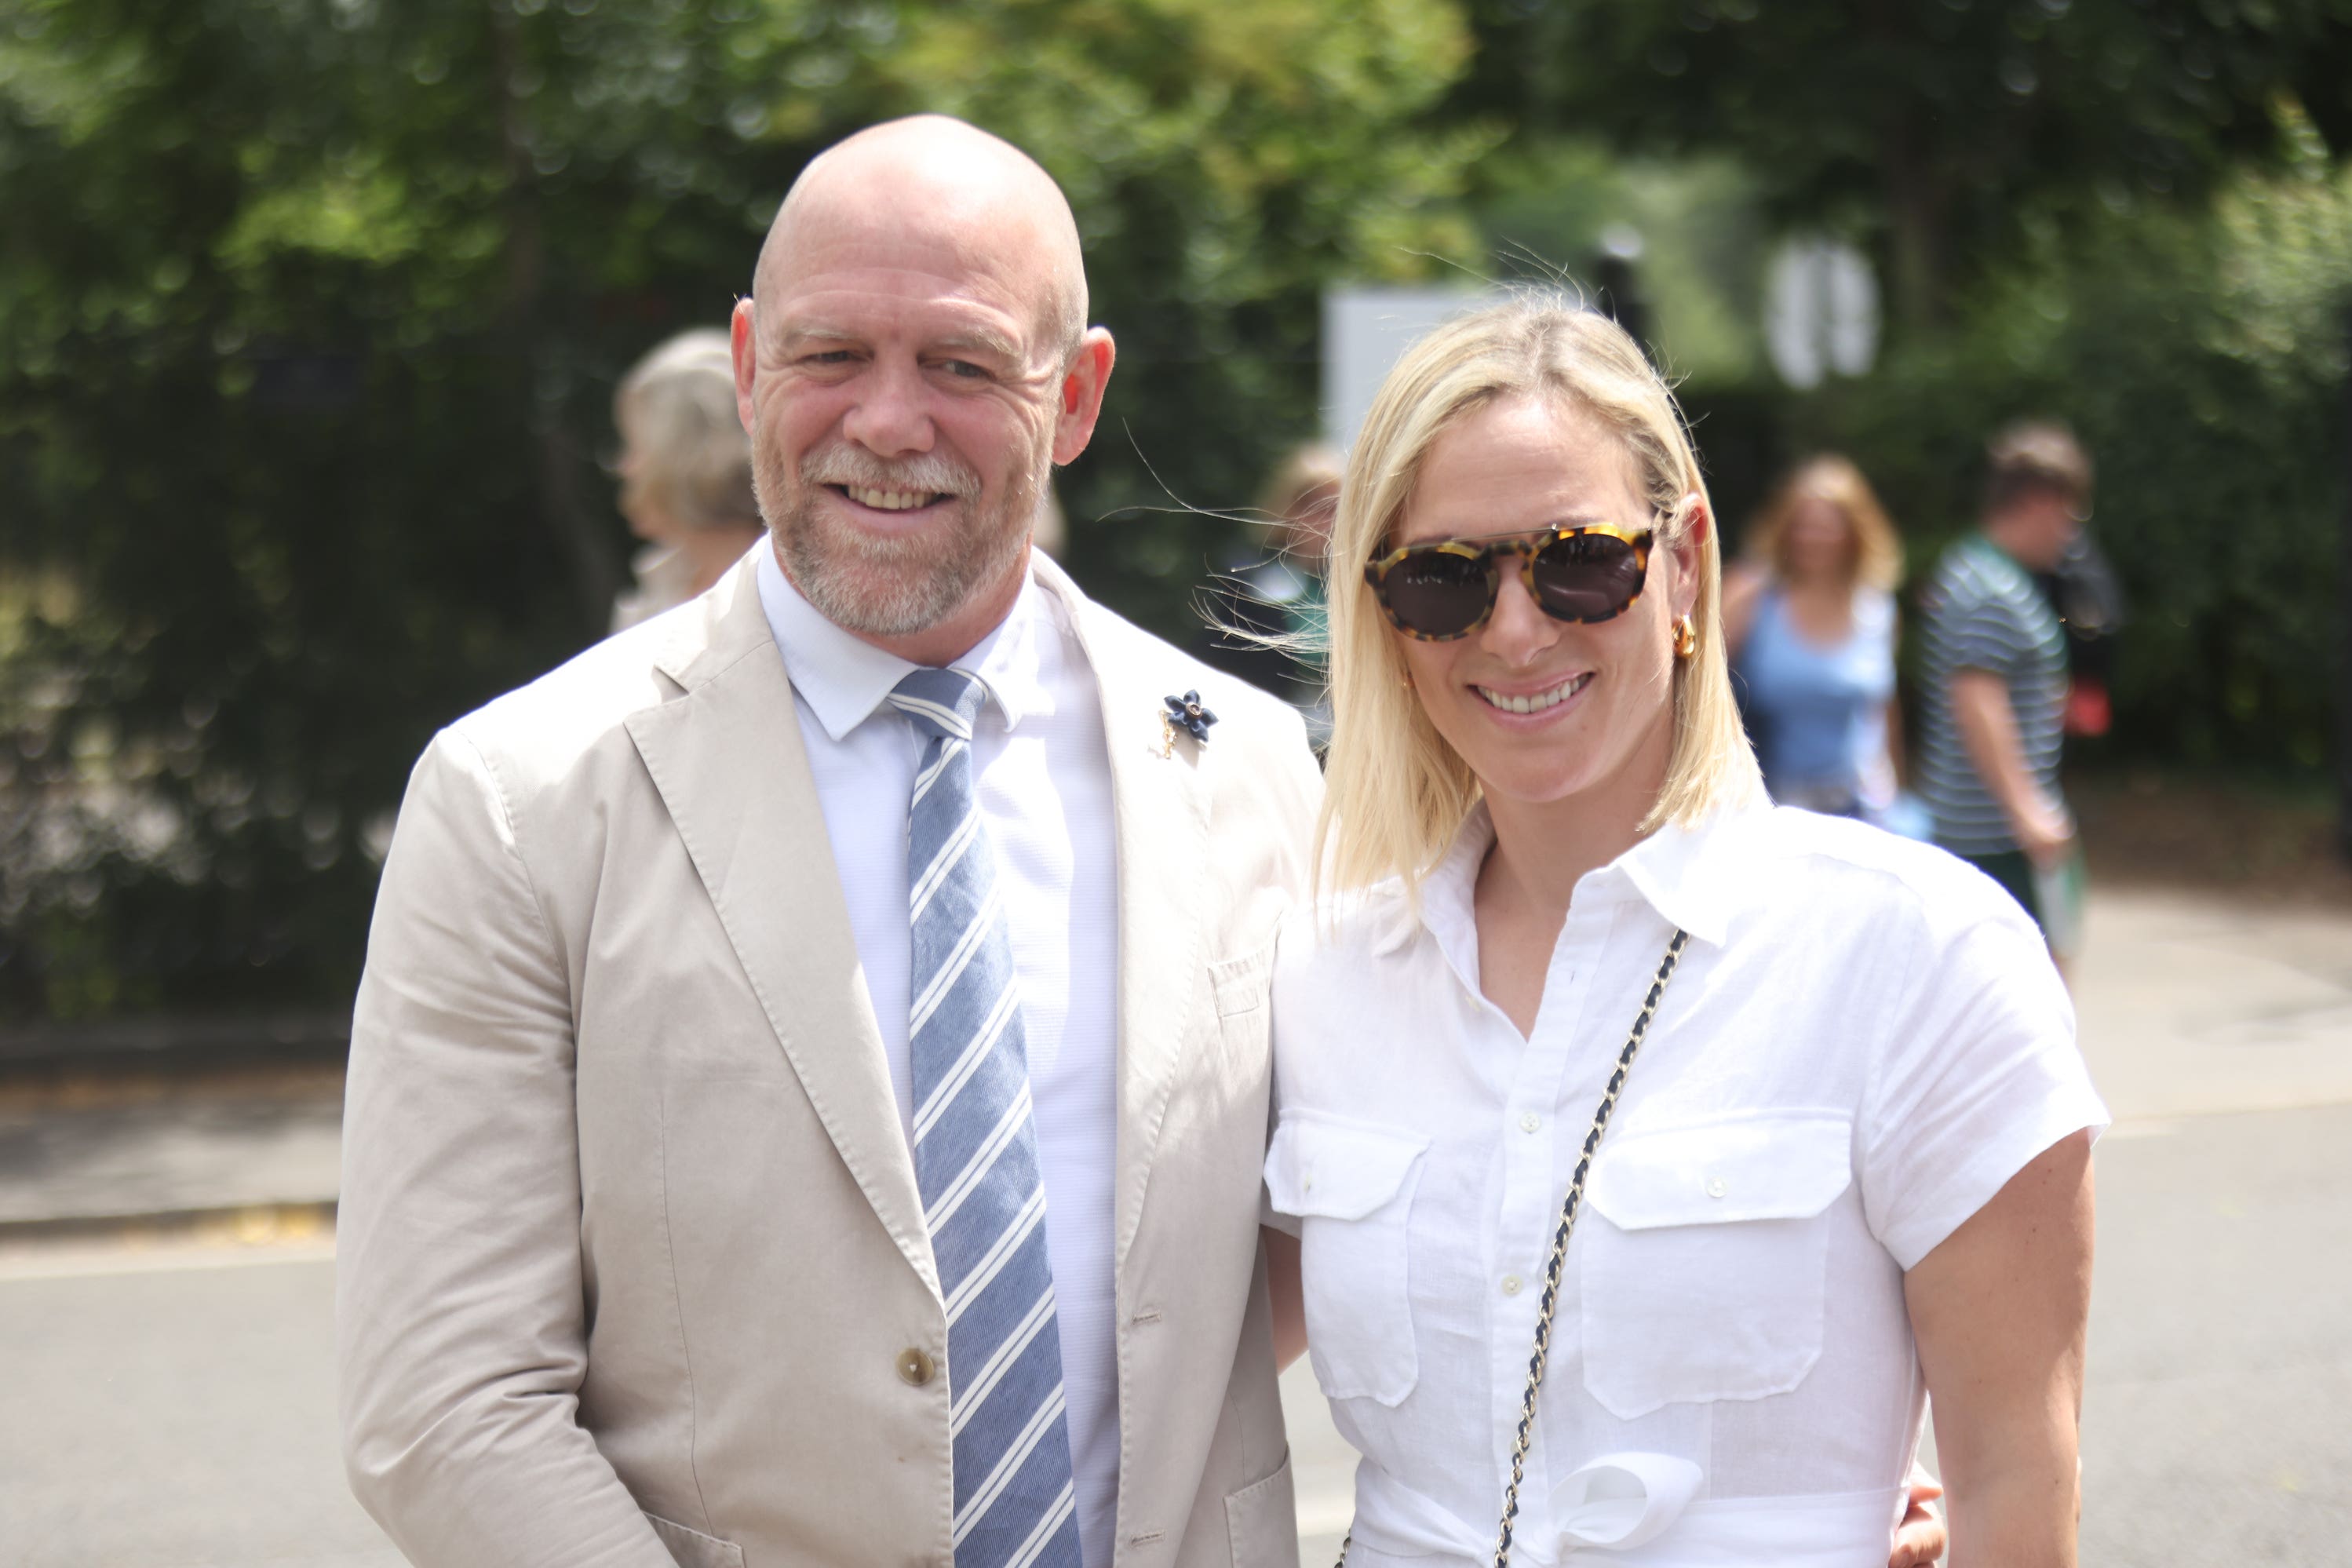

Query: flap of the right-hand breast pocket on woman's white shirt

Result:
[1588,1112,1854,1230]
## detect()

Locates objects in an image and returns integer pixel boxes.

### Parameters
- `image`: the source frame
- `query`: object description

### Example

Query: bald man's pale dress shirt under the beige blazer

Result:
[760,548,1120,1568]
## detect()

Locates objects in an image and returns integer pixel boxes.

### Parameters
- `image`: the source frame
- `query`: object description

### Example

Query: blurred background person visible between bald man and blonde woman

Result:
[1197,442,1340,748]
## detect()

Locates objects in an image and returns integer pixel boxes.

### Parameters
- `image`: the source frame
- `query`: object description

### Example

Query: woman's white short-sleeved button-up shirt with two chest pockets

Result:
[1265,808,2107,1568]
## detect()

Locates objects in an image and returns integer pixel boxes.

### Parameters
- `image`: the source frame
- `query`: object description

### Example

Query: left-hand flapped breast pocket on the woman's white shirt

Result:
[1265,1112,1430,1406]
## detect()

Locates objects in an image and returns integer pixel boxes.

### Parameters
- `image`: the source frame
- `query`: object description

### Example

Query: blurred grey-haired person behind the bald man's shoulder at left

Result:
[611,326,762,633]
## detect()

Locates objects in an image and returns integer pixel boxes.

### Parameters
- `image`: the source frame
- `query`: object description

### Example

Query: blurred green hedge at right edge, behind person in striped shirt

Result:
[1785,158,2352,774]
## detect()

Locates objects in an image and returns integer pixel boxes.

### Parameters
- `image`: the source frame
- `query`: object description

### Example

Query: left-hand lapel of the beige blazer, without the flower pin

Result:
[628,557,939,1291]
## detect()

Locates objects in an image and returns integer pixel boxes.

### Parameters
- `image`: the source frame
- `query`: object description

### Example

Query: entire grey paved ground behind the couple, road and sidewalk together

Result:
[0,893,2352,1568]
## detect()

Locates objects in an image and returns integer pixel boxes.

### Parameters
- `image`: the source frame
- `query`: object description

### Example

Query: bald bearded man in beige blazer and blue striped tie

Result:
[337,118,1317,1568]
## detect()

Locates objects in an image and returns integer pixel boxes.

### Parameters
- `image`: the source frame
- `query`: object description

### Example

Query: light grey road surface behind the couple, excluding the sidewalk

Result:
[0,1107,2352,1568]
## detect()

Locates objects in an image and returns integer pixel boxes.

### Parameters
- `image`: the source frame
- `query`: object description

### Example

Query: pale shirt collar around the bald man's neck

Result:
[760,548,1056,741]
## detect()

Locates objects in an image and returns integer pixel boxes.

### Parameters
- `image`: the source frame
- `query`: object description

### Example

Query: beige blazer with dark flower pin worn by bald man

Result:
[337,560,1319,1568]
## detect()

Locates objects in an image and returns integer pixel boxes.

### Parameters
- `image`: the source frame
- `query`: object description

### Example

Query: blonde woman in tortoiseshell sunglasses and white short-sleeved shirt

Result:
[1265,301,2105,1568]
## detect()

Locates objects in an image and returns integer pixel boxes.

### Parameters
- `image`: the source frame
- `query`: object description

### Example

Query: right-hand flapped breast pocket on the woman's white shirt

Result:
[1576,1112,1854,1420]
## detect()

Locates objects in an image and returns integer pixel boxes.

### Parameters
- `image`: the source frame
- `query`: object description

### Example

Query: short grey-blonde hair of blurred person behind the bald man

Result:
[611,326,760,529]
